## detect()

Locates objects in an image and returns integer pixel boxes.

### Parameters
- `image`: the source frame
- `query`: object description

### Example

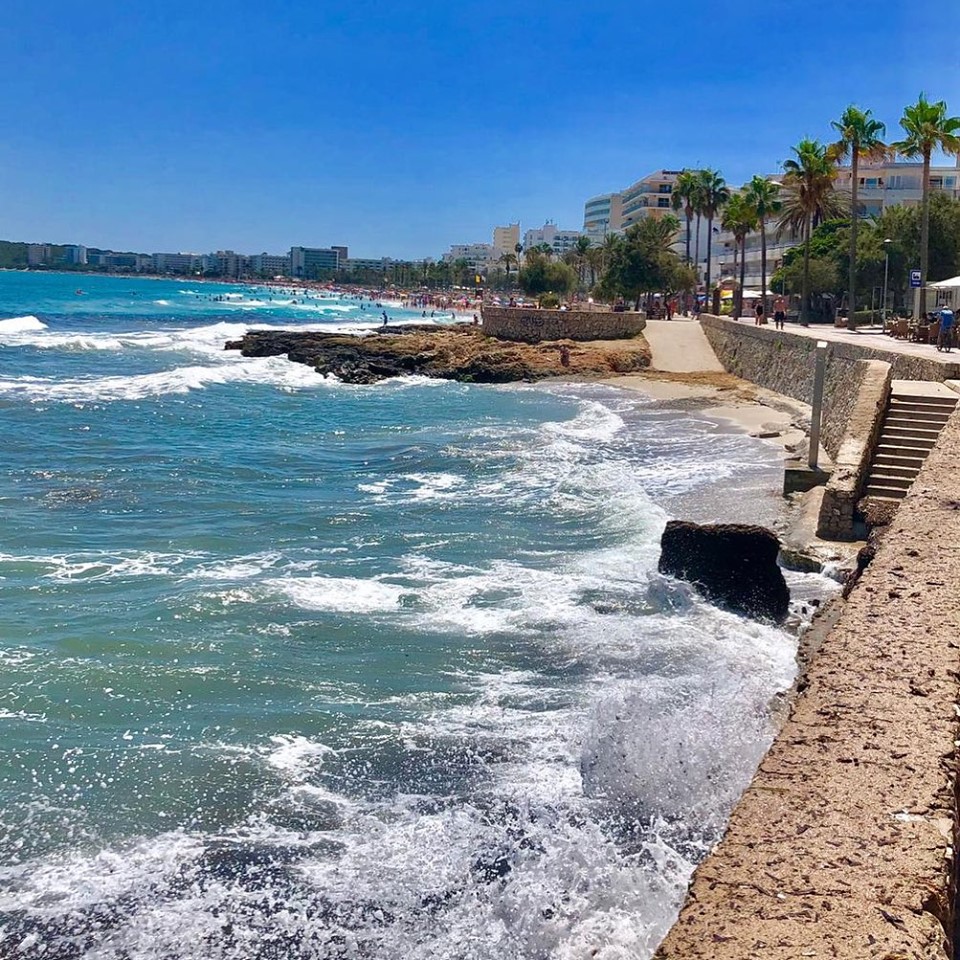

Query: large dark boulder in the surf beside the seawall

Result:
[659,520,790,623]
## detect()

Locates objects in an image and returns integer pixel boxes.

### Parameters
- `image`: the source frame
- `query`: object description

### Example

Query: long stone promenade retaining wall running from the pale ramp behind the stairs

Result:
[700,314,960,457]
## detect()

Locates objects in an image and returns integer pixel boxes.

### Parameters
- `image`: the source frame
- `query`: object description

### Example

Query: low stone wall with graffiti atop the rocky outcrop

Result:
[483,307,647,343]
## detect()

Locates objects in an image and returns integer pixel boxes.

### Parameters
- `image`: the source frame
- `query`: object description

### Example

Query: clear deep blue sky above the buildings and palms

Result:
[0,0,960,257]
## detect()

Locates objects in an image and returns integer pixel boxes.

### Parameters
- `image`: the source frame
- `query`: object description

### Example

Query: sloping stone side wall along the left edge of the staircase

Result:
[817,360,892,540]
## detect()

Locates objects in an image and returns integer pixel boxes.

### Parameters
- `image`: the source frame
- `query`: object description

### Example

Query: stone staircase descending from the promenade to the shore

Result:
[864,380,960,500]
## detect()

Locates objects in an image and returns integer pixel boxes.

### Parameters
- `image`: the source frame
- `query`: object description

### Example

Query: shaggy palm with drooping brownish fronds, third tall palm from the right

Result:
[779,139,840,326]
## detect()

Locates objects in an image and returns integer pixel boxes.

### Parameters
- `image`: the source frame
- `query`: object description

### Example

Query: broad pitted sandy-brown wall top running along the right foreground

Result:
[656,402,960,960]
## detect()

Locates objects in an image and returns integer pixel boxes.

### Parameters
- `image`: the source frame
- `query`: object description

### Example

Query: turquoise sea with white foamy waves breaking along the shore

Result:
[0,272,835,960]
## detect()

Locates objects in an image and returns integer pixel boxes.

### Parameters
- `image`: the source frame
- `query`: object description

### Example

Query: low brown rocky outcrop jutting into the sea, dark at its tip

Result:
[226,324,650,383]
